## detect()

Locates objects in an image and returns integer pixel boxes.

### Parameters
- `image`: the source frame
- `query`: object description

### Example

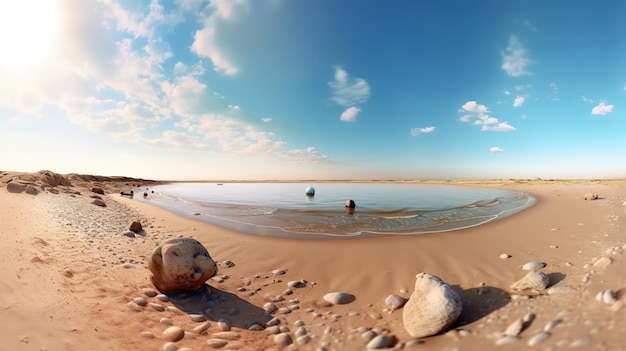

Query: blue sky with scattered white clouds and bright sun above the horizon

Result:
[0,0,626,180]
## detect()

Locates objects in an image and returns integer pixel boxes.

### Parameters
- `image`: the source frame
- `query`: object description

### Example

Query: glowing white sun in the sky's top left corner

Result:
[0,0,58,70]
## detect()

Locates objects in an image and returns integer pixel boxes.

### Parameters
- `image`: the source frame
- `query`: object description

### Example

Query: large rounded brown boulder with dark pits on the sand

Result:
[148,238,217,293]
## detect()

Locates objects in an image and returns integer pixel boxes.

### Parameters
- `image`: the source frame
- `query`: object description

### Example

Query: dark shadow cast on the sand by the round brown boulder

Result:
[163,284,272,329]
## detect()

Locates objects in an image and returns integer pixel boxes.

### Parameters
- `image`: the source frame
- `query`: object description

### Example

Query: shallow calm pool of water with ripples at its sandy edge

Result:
[136,183,535,238]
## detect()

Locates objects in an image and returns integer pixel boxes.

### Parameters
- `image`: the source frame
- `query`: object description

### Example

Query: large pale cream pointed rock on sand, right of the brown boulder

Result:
[402,273,463,338]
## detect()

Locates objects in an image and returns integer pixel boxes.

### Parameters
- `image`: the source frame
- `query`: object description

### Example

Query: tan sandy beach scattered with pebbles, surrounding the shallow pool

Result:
[0,172,626,350]
